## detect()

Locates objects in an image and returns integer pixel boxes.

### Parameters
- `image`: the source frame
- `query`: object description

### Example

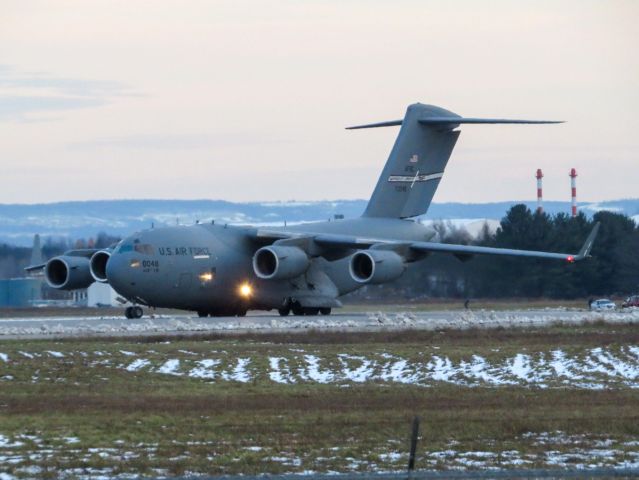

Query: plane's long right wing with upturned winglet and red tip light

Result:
[304,223,599,263]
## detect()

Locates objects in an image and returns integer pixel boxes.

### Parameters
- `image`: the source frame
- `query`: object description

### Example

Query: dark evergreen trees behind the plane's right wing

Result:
[357,205,639,299]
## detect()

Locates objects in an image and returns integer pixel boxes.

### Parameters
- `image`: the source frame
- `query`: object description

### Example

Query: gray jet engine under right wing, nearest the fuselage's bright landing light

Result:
[253,245,311,280]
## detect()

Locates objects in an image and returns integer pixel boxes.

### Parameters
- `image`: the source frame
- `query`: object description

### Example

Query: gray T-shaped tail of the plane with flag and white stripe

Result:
[348,103,562,218]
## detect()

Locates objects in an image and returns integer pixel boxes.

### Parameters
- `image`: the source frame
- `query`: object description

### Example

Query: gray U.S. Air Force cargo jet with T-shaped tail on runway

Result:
[27,103,599,318]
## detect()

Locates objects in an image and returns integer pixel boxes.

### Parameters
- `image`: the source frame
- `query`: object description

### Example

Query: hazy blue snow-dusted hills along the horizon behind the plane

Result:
[0,199,639,246]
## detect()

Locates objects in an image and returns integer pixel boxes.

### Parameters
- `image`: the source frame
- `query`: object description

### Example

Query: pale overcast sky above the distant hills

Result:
[0,0,639,203]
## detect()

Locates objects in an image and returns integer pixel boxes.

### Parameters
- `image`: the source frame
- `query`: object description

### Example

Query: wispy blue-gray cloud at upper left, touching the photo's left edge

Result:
[0,65,137,121]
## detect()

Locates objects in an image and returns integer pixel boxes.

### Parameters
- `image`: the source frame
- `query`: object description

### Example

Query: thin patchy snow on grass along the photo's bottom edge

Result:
[0,431,639,474]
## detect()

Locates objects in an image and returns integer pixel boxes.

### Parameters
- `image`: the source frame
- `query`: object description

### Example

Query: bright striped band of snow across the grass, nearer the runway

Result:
[135,346,639,389]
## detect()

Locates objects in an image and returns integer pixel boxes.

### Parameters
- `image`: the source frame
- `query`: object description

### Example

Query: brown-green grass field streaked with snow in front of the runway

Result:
[0,323,639,478]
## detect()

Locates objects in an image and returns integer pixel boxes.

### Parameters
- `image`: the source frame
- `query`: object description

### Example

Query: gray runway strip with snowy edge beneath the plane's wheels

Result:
[0,308,639,340]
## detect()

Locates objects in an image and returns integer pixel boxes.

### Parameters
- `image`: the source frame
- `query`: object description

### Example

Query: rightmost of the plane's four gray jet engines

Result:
[348,250,406,284]
